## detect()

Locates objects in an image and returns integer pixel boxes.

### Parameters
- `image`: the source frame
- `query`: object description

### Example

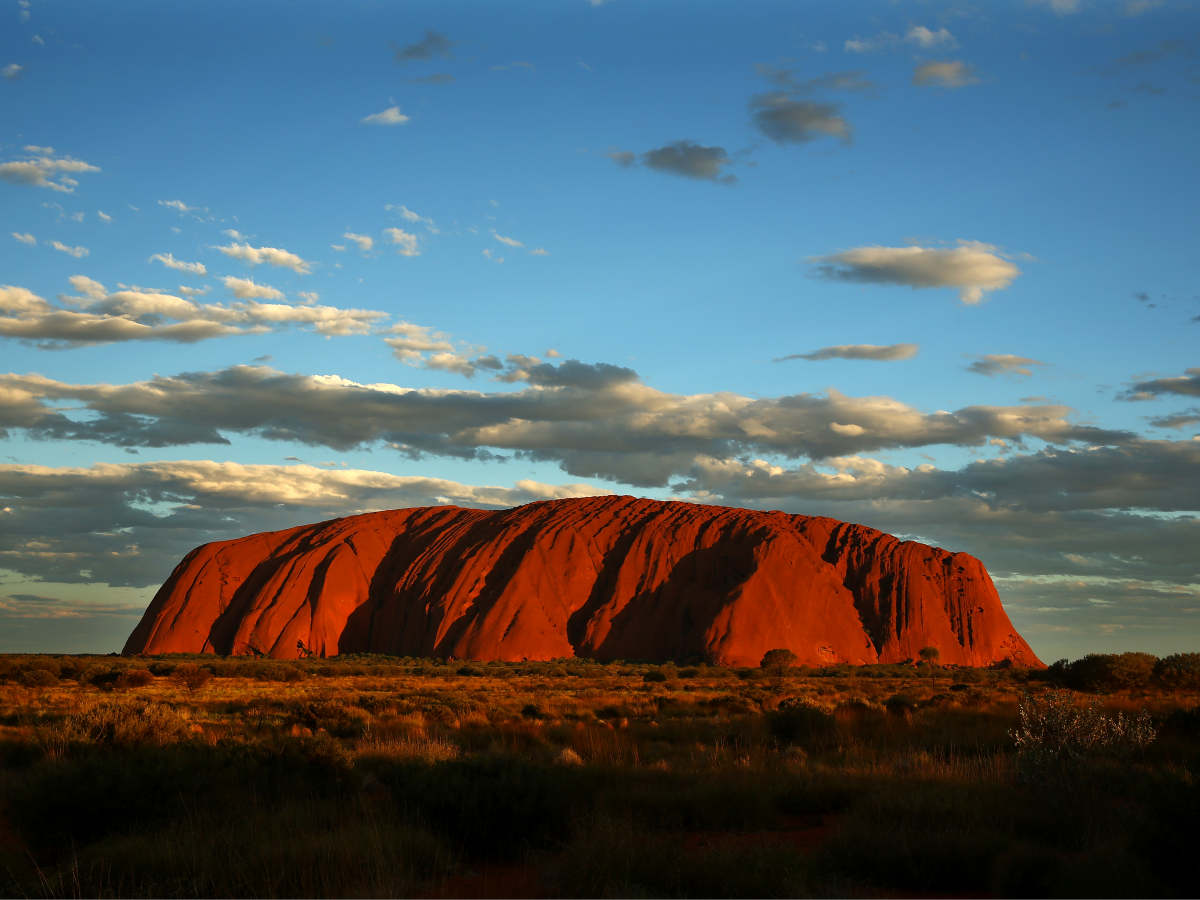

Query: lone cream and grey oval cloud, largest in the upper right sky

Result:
[809,240,1021,305]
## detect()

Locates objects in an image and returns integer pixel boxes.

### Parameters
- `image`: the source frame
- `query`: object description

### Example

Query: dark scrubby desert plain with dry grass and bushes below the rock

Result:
[0,653,1200,899]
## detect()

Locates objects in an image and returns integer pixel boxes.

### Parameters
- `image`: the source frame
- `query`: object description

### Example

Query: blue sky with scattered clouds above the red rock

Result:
[0,0,1200,661]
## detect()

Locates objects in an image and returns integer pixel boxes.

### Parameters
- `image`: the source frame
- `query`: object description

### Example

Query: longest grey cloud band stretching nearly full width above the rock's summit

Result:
[0,362,1136,475]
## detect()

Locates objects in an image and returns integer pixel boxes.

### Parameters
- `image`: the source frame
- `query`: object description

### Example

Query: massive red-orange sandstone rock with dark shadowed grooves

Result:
[125,497,1042,666]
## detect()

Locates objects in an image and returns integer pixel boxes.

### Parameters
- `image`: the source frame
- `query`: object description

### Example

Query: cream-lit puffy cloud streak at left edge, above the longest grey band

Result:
[0,275,386,348]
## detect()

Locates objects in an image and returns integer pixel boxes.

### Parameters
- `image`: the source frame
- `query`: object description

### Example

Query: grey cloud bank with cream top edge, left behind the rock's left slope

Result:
[0,461,611,588]
